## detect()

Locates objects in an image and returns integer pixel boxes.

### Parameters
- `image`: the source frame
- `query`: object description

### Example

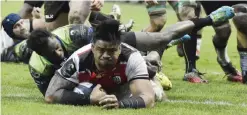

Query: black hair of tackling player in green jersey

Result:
[27,29,52,55]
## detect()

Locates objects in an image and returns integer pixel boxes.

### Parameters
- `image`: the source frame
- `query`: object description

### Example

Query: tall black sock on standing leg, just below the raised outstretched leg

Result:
[183,32,197,73]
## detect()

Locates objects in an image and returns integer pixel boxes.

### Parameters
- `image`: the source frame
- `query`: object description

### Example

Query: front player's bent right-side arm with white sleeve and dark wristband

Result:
[118,52,155,108]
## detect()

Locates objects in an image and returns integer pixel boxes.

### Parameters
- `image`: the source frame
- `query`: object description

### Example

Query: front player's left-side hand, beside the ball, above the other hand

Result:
[90,84,107,105]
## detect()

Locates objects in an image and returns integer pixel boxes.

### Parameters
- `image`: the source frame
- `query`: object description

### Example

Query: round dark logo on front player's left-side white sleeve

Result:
[61,59,76,78]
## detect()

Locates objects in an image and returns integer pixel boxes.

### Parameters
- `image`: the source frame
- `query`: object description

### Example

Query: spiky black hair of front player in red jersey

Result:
[93,19,120,44]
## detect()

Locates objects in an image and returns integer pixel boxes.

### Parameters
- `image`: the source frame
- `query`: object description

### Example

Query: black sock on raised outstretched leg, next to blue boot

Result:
[190,16,213,31]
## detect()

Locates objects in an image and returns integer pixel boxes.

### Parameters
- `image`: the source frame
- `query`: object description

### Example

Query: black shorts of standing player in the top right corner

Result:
[200,1,247,15]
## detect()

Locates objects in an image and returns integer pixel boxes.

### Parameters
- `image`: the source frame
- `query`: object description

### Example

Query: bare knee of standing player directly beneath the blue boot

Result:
[214,23,231,39]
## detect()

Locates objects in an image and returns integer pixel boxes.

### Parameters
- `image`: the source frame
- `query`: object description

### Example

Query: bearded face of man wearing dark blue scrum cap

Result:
[13,19,30,38]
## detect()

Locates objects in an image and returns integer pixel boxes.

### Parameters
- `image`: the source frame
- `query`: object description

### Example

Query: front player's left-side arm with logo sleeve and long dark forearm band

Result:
[45,56,90,105]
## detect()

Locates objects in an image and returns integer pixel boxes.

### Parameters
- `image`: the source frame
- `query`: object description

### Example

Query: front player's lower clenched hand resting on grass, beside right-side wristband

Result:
[99,95,119,109]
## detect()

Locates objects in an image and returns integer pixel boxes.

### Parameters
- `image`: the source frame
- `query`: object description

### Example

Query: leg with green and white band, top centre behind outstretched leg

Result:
[143,1,166,32]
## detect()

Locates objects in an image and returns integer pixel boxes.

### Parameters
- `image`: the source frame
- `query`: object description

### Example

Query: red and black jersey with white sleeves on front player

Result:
[57,44,149,90]
